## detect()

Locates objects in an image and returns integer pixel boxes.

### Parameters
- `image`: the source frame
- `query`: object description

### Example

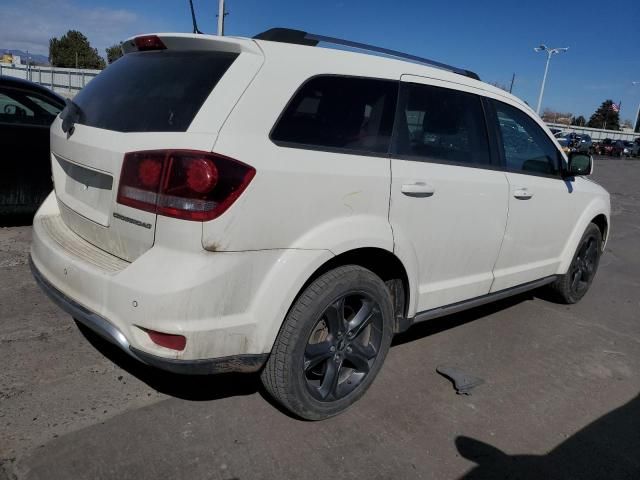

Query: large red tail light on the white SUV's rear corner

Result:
[117,150,256,221]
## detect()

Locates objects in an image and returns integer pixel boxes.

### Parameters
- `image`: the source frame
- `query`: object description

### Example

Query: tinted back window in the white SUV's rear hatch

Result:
[73,51,238,132]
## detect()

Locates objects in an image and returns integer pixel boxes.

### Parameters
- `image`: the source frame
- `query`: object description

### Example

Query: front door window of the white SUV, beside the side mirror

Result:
[494,101,559,175]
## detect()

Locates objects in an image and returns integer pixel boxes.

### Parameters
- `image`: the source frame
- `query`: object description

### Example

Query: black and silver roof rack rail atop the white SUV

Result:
[253,28,480,80]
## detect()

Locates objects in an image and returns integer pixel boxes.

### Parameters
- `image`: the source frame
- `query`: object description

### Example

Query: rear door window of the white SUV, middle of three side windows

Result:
[396,83,491,165]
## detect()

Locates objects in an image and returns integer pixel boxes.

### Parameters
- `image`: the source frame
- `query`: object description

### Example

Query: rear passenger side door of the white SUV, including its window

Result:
[390,76,508,311]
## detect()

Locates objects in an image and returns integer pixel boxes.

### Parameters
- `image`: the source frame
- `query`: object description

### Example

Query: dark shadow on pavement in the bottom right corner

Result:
[455,395,640,480]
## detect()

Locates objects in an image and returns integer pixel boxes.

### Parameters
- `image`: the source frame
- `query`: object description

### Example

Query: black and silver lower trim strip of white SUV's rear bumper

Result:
[29,258,269,375]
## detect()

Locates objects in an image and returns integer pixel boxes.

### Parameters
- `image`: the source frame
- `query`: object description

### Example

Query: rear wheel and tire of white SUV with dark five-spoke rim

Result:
[261,265,394,420]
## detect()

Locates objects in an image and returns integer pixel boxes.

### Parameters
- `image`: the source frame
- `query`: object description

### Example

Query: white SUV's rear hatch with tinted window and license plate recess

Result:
[51,34,262,261]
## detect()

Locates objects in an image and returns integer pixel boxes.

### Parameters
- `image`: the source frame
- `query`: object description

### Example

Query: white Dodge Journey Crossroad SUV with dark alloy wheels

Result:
[31,29,610,419]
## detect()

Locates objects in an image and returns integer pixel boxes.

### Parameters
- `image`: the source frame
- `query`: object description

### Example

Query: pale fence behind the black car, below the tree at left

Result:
[0,63,101,97]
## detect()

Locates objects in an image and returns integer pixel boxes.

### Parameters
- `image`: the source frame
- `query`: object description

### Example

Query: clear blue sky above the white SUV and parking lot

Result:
[0,0,640,119]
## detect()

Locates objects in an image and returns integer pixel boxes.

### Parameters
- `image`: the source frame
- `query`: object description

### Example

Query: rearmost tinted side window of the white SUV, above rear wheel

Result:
[271,76,398,153]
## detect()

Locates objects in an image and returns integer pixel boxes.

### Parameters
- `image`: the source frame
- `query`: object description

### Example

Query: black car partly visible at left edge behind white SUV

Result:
[0,76,65,215]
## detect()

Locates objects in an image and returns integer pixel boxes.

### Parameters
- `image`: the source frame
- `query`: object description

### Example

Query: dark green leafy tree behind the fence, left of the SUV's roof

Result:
[49,30,106,69]
